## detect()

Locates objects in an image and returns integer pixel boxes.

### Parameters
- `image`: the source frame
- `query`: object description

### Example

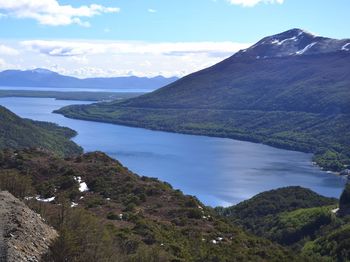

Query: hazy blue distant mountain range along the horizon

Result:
[0,68,178,90]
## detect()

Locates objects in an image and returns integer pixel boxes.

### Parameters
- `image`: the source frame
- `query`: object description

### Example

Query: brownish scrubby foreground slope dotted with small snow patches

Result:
[0,150,297,261]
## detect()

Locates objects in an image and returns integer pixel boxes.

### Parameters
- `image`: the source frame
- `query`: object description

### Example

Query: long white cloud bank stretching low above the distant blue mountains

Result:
[0,40,249,78]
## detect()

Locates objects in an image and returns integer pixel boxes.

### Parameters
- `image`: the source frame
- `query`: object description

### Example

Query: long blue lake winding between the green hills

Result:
[0,98,345,206]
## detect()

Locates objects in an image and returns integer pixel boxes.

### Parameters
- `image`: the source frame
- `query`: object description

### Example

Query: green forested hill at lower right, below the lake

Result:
[216,185,350,261]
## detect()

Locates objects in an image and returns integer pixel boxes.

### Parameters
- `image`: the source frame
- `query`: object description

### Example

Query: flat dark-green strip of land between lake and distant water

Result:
[0,90,144,101]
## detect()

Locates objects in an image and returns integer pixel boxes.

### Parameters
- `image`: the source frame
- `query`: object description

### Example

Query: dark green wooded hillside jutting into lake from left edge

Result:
[0,106,82,156]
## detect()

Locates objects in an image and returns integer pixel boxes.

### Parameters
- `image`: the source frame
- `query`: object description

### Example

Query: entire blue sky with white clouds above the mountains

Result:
[0,0,350,78]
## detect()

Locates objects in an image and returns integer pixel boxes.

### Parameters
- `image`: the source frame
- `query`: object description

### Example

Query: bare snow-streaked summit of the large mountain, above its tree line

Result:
[236,29,350,59]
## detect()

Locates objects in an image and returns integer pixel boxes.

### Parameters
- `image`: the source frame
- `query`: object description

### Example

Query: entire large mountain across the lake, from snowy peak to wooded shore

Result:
[57,29,350,171]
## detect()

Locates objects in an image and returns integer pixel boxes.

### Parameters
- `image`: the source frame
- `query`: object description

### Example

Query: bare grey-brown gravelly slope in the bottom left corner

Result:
[0,191,57,262]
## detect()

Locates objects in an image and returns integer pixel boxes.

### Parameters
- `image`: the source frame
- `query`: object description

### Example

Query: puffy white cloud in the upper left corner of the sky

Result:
[0,0,120,26]
